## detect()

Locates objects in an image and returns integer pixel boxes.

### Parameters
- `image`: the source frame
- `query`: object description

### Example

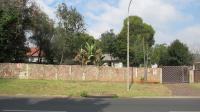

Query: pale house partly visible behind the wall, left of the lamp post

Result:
[103,54,123,68]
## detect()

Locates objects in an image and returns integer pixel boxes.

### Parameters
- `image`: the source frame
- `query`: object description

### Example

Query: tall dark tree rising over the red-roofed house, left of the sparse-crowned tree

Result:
[28,7,54,63]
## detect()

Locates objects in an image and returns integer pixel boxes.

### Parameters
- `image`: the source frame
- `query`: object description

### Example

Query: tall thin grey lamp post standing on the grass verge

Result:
[127,0,132,91]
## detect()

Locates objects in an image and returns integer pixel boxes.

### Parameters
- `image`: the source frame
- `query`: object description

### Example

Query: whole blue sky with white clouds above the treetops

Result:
[35,0,200,49]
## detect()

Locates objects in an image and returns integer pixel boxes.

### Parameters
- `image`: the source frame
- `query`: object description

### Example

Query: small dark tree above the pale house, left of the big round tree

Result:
[100,30,116,57]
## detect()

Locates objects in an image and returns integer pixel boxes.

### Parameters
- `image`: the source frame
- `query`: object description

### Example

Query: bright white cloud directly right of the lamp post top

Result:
[132,0,182,25]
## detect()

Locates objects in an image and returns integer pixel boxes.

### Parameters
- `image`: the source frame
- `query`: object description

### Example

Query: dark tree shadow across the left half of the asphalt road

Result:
[0,98,109,112]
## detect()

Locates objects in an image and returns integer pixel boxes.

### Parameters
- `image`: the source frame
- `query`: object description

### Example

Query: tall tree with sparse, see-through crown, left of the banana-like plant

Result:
[54,3,85,64]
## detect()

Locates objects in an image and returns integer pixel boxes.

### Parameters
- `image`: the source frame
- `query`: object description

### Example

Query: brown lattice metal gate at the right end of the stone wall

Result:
[162,66,189,83]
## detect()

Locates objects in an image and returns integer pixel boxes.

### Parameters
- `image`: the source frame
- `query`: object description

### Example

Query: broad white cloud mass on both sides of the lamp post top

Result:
[86,0,183,37]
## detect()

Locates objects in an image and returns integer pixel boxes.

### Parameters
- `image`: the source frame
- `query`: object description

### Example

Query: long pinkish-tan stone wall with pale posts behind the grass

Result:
[0,63,162,82]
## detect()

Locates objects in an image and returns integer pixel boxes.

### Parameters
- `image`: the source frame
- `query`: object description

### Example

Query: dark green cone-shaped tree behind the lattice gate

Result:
[167,40,193,66]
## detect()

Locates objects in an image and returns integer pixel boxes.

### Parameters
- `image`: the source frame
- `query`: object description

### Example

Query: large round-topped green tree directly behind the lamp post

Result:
[114,16,155,66]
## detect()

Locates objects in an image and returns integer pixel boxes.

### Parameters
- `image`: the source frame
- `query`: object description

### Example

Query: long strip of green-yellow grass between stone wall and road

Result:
[0,79,171,97]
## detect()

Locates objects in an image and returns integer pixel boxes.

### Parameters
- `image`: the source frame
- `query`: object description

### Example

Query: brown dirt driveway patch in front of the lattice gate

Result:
[165,84,200,96]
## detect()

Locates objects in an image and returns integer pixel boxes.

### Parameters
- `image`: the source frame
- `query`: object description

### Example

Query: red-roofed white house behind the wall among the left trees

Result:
[26,47,47,63]
